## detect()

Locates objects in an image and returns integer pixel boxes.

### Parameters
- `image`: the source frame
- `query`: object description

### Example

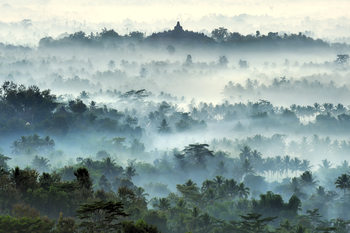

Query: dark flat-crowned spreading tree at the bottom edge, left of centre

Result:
[77,201,128,233]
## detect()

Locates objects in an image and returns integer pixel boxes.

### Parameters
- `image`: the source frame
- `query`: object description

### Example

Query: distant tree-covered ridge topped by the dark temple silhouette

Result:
[39,22,349,50]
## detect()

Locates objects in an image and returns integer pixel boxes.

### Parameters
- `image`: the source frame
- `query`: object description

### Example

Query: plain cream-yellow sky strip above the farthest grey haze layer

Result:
[0,0,350,22]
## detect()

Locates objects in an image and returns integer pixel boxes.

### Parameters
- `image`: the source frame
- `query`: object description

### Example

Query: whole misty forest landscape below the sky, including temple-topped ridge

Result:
[0,22,350,233]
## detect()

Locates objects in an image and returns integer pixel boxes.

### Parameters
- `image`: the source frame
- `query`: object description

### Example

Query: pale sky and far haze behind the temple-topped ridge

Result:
[0,0,350,45]
